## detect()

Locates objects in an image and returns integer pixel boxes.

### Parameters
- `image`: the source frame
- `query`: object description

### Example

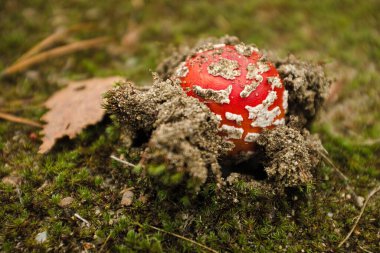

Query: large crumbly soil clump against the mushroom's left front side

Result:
[105,75,233,188]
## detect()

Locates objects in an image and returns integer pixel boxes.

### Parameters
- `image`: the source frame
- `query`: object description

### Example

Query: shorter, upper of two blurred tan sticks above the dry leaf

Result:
[16,24,90,62]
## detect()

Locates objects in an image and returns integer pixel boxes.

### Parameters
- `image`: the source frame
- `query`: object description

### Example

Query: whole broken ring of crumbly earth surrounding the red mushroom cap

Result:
[105,36,330,192]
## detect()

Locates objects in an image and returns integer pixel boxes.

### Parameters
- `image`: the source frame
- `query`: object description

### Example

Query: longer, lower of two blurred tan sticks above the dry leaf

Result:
[0,37,109,77]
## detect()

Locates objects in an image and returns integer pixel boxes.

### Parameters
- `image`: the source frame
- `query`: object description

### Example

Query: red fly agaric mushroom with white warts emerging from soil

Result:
[174,44,288,154]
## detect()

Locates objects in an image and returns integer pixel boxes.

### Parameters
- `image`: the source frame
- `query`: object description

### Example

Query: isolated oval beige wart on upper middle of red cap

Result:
[207,58,241,80]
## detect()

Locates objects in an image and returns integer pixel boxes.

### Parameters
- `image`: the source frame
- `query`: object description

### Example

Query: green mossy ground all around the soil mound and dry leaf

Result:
[0,0,380,252]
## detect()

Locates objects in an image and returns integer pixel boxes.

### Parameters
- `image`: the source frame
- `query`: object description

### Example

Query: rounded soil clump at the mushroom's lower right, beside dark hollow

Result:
[256,117,322,188]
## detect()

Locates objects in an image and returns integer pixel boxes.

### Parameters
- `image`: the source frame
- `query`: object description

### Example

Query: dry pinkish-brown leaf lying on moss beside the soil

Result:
[38,76,123,154]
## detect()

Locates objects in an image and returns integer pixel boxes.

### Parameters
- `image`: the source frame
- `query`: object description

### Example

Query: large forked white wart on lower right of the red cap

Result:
[245,91,281,128]
